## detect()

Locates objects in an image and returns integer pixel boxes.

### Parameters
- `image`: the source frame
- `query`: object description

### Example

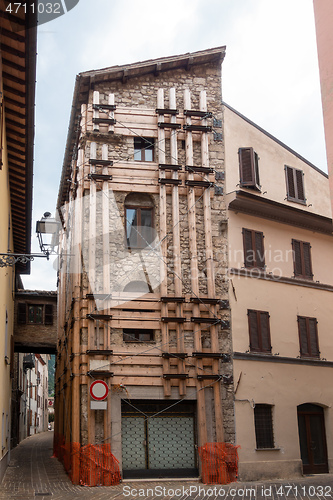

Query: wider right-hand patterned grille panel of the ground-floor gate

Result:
[148,417,195,469]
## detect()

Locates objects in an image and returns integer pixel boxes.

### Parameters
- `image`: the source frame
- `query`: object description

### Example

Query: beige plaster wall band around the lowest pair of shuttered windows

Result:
[230,276,333,361]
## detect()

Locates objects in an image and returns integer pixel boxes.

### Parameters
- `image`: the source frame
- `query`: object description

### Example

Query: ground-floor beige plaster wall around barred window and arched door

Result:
[234,360,333,479]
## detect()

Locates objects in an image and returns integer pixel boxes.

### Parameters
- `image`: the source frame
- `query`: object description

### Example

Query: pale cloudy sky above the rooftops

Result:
[23,0,327,290]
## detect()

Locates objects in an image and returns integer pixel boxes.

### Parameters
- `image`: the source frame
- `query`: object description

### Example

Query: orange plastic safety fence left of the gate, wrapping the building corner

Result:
[54,435,121,486]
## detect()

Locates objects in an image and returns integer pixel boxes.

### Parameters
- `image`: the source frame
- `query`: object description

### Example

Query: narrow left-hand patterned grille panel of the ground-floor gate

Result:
[121,416,147,469]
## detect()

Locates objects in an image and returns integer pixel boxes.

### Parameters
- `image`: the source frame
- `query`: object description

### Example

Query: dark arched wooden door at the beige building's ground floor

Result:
[297,403,328,474]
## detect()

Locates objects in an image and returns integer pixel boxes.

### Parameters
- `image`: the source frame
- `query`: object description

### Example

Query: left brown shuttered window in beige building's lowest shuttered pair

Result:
[247,309,272,353]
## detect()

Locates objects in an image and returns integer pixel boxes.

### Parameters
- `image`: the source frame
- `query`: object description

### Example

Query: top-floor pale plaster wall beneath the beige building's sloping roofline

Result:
[224,106,331,217]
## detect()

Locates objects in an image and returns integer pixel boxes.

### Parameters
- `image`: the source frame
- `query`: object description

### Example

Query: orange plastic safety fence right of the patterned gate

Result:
[199,443,239,484]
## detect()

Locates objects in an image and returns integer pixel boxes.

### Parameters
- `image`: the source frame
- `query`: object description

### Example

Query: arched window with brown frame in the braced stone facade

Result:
[125,193,154,248]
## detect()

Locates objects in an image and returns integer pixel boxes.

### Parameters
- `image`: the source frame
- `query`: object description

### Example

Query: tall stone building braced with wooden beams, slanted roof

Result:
[55,47,235,484]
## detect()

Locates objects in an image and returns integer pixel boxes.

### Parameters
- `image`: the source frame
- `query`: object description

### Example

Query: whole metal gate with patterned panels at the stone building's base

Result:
[122,401,198,479]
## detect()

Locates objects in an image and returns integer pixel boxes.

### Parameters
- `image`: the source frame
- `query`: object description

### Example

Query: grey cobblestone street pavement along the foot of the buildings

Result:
[0,432,333,500]
